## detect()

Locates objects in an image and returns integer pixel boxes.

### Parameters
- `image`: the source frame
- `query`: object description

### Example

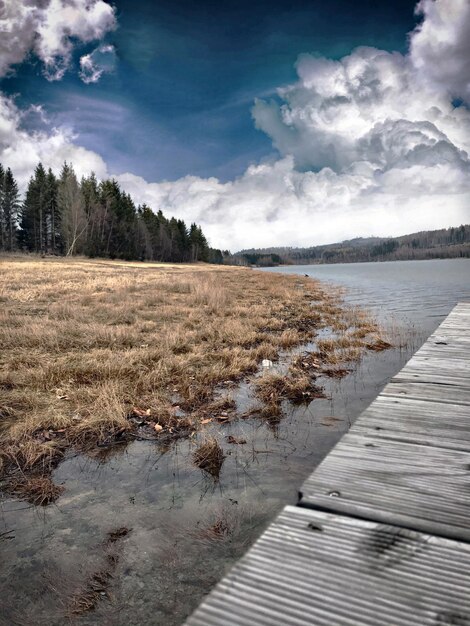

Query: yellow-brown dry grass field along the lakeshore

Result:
[0,251,390,503]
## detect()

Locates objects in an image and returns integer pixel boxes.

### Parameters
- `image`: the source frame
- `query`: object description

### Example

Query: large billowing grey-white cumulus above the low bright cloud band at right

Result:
[253,48,470,171]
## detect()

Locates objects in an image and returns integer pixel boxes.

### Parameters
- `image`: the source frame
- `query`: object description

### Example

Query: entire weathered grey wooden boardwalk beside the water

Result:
[187,303,470,626]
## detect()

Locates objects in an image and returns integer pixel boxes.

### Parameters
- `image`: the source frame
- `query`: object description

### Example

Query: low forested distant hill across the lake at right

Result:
[231,224,470,266]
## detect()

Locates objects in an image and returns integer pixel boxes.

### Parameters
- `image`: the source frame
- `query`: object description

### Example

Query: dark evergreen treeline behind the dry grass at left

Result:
[0,163,223,263]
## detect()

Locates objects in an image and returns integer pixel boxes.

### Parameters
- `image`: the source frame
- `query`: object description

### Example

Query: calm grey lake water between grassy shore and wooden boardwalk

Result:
[0,260,470,626]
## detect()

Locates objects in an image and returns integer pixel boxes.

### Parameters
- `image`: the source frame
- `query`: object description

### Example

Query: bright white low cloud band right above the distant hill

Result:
[117,157,470,251]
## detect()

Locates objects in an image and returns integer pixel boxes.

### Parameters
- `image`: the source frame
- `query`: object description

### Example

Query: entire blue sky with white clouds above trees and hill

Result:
[0,0,470,251]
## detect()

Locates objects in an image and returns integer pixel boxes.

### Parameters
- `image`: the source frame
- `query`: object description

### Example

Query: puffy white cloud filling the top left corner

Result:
[0,0,116,80]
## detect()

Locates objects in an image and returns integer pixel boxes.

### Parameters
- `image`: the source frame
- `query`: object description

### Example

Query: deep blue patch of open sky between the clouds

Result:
[1,0,416,181]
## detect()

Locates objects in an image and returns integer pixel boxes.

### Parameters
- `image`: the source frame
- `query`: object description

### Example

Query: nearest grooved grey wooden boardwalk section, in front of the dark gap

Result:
[186,507,470,626]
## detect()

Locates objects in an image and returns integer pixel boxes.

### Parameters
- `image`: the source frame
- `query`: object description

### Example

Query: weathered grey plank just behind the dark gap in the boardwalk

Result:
[302,433,470,541]
